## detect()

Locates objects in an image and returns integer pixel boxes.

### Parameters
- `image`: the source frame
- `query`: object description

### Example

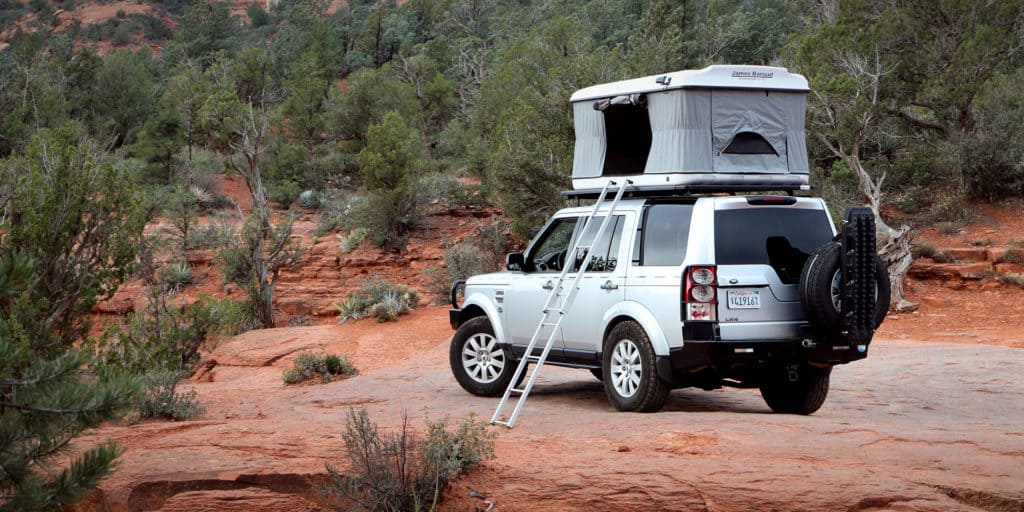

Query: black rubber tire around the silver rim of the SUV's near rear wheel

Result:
[601,321,672,413]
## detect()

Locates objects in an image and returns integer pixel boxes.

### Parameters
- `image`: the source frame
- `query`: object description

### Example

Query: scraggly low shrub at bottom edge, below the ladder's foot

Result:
[323,408,495,511]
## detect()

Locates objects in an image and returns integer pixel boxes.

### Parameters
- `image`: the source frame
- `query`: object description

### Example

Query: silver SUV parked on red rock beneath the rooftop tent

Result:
[450,194,888,414]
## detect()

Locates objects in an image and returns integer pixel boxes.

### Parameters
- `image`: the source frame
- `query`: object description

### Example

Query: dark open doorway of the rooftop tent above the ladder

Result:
[602,101,651,176]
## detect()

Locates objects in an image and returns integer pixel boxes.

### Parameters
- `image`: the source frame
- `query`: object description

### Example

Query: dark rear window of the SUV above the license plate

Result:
[715,207,833,284]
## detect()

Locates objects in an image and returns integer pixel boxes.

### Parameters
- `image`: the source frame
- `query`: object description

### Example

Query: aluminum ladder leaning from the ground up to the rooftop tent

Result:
[490,180,633,428]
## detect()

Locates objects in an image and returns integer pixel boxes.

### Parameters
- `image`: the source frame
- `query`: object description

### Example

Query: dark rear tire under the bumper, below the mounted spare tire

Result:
[761,365,831,415]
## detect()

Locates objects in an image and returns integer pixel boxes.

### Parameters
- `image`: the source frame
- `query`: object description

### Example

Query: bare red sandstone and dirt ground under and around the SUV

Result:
[78,185,1024,511]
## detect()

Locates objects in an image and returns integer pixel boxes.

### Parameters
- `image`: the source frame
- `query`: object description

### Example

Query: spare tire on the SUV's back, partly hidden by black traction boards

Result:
[800,242,891,334]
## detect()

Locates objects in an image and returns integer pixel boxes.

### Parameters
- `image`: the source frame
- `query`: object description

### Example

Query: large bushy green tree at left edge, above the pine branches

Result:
[0,124,146,339]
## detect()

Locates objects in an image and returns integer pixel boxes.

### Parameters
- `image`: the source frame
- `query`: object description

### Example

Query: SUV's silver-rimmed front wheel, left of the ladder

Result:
[449,316,516,396]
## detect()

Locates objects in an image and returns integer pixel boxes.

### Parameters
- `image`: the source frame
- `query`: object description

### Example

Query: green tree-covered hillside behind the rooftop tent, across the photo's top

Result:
[0,0,1024,236]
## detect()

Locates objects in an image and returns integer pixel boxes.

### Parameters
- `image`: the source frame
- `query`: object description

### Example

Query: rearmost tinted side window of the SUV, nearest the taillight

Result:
[639,205,693,266]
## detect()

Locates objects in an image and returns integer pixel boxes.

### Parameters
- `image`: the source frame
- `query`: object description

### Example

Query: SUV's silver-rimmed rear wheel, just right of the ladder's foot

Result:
[602,322,671,413]
